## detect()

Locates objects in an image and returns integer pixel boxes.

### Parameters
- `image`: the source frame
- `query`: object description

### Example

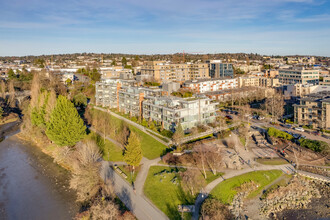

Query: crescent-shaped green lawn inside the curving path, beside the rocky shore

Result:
[211,170,282,204]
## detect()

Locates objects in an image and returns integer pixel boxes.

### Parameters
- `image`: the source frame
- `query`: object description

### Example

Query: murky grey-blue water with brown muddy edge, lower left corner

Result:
[0,136,78,220]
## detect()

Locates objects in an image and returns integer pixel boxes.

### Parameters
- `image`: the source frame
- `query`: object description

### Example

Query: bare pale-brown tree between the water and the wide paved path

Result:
[70,141,102,202]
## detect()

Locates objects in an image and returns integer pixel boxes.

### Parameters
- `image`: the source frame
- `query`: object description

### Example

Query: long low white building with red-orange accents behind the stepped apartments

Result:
[183,78,238,93]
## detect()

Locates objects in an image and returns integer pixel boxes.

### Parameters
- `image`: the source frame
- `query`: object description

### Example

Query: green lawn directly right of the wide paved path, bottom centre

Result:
[144,166,194,219]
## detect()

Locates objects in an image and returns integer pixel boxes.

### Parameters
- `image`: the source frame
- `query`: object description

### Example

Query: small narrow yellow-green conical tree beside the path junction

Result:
[124,132,142,173]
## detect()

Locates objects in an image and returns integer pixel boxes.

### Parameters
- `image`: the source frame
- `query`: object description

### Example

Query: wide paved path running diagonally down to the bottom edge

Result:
[101,161,168,220]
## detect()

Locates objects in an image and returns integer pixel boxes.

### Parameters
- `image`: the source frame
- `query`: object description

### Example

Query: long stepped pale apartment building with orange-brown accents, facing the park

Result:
[95,79,216,129]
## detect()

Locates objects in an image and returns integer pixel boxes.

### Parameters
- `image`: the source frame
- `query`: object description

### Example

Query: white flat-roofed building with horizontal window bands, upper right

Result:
[278,69,319,84]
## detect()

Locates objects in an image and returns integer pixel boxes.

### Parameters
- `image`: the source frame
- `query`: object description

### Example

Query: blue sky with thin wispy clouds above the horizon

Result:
[0,0,330,56]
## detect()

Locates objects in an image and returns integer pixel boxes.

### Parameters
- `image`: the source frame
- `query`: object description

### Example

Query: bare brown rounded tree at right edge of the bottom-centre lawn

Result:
[180,169,206,196]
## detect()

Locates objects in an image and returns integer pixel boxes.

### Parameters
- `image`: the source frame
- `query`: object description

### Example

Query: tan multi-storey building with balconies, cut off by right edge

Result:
[294,91,330,129]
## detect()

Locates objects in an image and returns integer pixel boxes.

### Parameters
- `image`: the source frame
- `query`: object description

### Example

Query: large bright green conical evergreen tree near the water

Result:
[46,96,86,146]
